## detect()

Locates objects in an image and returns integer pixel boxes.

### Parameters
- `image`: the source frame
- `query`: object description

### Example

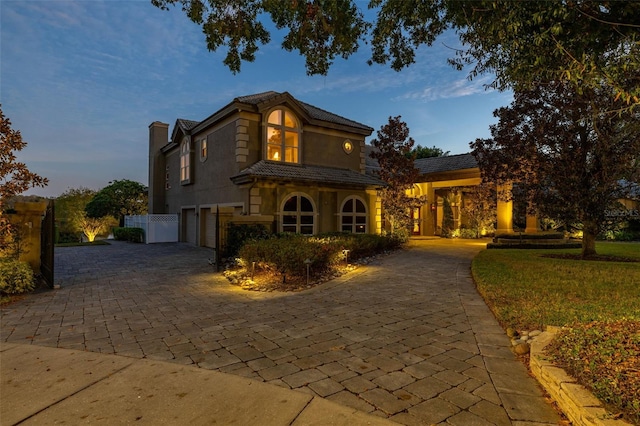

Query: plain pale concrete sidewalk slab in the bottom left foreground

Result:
[0,343,395,426]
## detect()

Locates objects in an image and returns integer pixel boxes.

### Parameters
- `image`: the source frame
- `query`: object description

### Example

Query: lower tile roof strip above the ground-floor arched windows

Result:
[231,160,384,186]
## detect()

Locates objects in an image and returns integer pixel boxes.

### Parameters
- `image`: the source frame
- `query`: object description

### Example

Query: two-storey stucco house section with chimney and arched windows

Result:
[149,91,383,247]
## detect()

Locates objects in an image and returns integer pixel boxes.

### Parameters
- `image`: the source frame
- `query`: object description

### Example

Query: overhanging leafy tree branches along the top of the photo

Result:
[151,0,640,109]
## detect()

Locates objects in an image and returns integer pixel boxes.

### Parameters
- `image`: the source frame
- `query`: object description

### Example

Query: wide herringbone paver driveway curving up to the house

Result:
[1,240,558,425]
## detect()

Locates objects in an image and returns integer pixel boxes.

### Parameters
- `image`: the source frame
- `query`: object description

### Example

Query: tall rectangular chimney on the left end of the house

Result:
[149,121,169,214]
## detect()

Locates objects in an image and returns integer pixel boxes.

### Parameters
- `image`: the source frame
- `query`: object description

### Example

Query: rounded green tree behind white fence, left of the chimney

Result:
[85,179,148,226]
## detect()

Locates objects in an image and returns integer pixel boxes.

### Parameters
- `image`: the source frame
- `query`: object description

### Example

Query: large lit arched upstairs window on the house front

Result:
[267,109,300,163]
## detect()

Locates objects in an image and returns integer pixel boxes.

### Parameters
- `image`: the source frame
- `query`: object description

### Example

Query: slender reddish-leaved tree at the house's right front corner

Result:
[370,116,426,236]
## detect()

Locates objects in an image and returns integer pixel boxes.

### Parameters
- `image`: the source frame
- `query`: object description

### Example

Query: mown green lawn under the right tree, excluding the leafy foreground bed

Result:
[472,242,640,330]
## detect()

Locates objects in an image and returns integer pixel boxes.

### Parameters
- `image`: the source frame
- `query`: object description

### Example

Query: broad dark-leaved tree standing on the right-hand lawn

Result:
[470,82,640,257]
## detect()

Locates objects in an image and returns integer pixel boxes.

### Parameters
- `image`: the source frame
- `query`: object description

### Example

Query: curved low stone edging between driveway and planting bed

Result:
[529,327,631,426]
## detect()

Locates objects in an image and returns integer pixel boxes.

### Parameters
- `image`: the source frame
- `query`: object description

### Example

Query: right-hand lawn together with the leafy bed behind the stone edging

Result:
[472,242,640,425]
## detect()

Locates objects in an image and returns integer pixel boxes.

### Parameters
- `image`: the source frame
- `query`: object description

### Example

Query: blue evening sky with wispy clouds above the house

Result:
[0,0,511,197]
